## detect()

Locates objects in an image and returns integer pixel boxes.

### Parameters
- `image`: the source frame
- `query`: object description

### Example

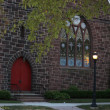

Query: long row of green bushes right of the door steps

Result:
[45,86,110,100]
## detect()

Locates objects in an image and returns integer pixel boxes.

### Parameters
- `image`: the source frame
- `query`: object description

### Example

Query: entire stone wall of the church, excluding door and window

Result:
[0,0,110,93]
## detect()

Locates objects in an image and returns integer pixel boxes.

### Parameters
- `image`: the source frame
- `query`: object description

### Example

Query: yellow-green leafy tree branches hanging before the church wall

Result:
[0,0,110,62]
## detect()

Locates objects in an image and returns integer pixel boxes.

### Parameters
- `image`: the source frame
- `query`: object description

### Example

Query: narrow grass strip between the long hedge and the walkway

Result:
[48,99,110,103]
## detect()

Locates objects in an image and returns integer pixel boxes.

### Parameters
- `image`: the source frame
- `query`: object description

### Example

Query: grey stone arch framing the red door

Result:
[7,51,36,91]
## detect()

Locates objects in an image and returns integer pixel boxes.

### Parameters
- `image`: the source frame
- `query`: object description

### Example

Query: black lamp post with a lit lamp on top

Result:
[91,52,98,107]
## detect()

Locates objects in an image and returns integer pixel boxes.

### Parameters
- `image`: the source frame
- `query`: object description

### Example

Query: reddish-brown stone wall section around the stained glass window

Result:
[50,16,110,90]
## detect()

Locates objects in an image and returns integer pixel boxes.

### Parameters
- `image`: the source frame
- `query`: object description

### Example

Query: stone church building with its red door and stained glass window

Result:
[0,0,110,93]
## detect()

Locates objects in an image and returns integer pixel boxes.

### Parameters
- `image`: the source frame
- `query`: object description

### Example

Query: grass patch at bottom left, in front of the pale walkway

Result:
[2,106,54,110]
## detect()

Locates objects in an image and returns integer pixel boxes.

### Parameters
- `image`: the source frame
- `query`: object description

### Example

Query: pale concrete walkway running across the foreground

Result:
[0,102,110,110]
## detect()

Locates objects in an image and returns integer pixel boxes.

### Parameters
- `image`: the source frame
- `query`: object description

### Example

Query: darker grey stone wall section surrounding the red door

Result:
[0,0,49,93]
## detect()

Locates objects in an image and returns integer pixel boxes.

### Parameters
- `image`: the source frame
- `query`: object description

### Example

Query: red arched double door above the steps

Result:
[11,57,31,91]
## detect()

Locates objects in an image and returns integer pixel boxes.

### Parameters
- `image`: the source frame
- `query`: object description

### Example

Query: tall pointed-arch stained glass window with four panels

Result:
[60,16,90,67]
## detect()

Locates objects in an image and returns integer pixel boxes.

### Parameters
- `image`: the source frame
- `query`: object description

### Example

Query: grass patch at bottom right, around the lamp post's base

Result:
[78,105,110,110]
